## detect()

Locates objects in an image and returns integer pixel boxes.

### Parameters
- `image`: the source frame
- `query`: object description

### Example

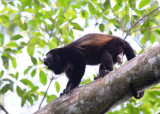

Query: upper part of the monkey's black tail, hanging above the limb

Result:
[124,41,136,61]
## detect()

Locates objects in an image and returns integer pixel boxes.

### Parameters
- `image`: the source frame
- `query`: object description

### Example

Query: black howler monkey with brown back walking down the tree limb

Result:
[44,33,144,98]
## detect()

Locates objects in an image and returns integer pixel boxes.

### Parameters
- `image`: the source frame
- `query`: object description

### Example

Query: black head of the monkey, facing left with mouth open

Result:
[44,49,66,74]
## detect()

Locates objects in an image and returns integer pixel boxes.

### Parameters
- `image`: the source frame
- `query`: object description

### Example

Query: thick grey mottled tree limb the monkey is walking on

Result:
[35,45,160,114]
